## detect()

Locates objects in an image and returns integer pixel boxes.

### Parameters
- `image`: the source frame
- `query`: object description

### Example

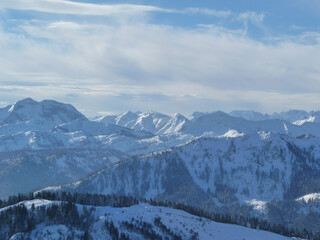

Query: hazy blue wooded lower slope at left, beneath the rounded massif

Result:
[0,148,127,199]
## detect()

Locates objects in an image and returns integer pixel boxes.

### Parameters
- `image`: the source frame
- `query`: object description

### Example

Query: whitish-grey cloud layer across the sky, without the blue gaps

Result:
[0,0,320,115]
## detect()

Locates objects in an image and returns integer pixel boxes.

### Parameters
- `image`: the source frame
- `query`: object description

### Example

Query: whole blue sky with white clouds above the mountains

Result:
[0,0,320,116]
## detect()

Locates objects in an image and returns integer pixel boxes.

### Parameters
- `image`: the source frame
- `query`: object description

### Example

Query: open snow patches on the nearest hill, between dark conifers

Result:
[4,200,291,240]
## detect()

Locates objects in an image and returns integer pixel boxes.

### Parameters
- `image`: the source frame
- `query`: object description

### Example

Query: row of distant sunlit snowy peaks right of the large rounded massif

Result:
[97,110,320,137]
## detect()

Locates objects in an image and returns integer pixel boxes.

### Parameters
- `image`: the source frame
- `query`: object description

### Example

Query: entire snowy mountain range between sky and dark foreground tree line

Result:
[0,98,320,237]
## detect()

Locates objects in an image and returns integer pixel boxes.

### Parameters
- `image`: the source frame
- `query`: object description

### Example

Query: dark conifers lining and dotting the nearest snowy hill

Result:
[0,191,320,240]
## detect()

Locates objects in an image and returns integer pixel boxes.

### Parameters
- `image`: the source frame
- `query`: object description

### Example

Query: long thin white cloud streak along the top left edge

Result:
[0,0,171,16]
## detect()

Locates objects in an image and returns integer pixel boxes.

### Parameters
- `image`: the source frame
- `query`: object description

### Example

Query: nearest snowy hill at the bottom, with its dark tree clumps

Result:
[0,196,298,240]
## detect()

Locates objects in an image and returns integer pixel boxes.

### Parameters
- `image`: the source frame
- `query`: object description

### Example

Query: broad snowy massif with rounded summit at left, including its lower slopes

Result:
[0,99,198,199]
